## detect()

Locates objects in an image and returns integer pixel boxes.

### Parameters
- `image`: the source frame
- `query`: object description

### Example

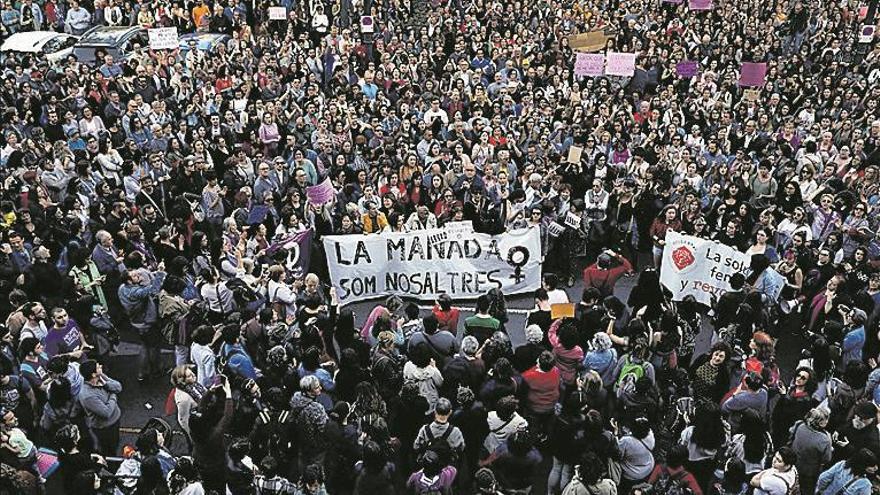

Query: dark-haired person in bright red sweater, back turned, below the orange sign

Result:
[522,351,562,434]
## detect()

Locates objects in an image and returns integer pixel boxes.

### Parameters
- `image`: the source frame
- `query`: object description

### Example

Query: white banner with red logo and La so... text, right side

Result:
[660,230,751,305]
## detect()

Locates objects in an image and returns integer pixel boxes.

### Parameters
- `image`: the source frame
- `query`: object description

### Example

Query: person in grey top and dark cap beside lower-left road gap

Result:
[79,360,122,456]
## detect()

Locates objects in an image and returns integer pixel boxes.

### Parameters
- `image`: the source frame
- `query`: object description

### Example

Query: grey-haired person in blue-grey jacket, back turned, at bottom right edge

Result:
[789,407,832,493]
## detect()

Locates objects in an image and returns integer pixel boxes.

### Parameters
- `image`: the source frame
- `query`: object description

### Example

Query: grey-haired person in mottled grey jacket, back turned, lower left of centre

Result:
[290,375,330,469]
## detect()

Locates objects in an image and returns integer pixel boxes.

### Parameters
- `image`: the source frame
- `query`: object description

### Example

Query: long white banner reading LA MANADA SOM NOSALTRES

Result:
[323,229,541,304]
